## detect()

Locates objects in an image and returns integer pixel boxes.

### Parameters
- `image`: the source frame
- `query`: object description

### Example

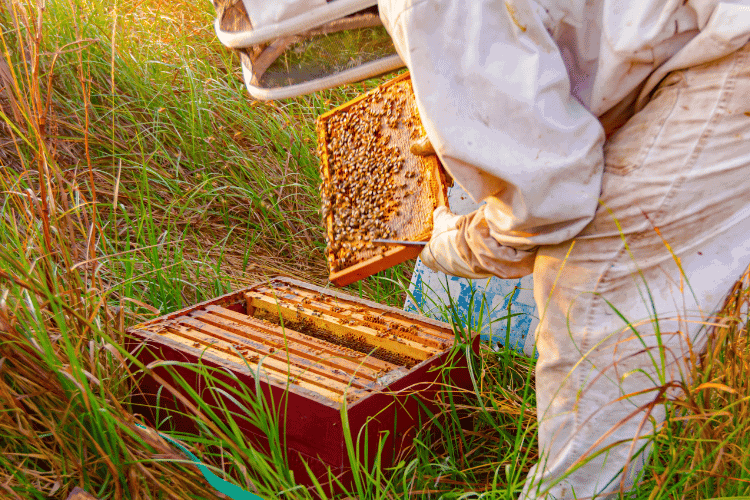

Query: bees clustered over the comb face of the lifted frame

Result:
[317,80,431,272]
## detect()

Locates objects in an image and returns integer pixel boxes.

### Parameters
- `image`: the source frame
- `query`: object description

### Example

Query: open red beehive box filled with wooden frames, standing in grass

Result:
[129,278,479,490]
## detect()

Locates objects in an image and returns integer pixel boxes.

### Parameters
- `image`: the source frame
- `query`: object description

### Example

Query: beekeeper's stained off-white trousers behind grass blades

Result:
[523,41,750,499]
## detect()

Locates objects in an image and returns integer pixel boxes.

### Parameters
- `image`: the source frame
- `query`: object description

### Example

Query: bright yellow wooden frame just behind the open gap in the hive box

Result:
[245,292,438,361]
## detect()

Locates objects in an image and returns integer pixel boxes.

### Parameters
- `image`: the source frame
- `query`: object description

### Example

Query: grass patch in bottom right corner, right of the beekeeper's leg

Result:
[646,271,750,499]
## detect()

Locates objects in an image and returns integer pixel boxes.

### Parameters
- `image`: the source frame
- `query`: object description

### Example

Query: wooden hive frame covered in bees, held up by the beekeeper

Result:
[317,73,447,286]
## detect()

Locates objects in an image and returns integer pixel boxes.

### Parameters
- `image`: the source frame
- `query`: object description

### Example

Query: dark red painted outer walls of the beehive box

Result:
[128,280,479,489]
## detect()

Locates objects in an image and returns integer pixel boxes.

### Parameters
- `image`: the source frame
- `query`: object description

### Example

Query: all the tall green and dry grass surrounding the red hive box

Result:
[0,0,750,500]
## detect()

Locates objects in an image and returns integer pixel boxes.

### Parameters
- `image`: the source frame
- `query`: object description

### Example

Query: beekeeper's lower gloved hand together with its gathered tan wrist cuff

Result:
[419,207,537,279]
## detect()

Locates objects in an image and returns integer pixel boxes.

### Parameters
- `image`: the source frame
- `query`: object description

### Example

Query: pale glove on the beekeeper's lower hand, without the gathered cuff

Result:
[419,206,492,278]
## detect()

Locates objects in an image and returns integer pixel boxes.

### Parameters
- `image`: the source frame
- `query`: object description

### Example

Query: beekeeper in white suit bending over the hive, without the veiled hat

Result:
[379,0,750,499]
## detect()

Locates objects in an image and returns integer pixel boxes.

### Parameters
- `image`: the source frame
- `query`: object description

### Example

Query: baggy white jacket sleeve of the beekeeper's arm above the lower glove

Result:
[379,0,604,254]
